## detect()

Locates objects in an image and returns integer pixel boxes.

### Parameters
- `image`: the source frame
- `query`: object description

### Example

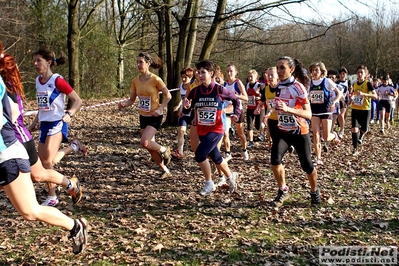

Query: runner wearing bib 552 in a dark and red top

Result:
[184,60,241,196]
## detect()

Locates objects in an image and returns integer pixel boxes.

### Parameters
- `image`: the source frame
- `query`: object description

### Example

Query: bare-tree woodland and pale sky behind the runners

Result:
[0,0,399,121]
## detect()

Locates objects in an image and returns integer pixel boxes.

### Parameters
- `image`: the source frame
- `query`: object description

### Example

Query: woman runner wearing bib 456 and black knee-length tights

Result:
[271,56,320,208]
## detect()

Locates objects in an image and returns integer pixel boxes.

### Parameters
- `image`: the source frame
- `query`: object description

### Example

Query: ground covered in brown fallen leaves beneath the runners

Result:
[0,101,399,265]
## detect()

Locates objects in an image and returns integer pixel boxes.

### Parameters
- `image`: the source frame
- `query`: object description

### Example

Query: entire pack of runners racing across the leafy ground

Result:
[0,47,397,254]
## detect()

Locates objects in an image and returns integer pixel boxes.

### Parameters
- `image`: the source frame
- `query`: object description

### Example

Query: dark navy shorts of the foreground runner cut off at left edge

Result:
[0,159,30,186]
